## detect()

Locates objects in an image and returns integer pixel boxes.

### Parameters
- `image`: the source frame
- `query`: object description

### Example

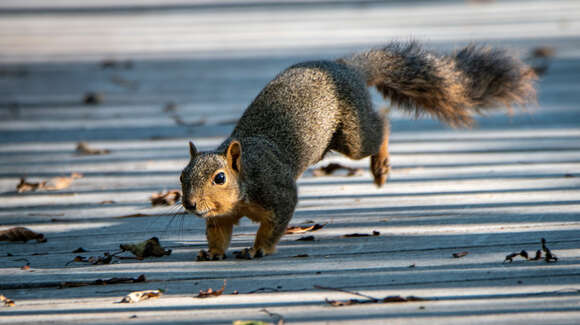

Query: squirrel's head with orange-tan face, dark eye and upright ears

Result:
[179,140,242,218]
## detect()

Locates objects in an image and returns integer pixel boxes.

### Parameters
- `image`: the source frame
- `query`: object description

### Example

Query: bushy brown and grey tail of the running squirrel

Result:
[338,42,536,126]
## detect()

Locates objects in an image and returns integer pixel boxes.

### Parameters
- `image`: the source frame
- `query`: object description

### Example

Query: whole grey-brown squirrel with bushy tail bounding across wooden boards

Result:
[180,42,536,260]
